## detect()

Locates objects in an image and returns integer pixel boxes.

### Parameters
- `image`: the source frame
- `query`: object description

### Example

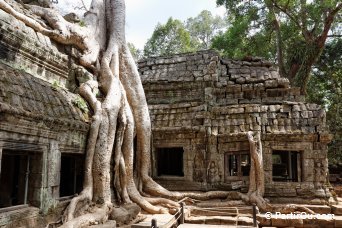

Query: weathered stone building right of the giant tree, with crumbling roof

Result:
[139,51,330,201]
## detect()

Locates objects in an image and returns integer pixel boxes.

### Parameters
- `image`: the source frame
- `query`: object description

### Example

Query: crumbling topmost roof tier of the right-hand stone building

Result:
[138,50,290,94]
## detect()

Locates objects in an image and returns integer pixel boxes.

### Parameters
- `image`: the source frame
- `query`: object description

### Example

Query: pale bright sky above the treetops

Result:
[59,0,225,49]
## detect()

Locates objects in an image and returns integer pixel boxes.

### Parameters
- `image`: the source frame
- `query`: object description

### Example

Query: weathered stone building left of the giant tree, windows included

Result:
[0,5,89,227]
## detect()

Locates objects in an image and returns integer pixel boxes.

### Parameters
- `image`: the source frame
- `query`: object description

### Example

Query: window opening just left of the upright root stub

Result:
[225,152,251,181]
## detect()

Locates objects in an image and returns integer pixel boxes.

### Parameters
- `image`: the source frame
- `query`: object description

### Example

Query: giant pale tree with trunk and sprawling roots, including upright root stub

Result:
[0,0,316,227]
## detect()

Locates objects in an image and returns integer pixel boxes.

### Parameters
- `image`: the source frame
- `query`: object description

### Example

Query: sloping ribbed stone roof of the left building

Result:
[0,63,89,132]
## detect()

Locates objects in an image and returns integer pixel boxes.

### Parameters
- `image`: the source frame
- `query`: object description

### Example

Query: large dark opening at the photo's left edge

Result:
[0,150,41,208]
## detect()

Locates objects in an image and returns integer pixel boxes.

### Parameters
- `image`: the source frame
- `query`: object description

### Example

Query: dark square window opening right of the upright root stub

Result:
[272,150,301,182]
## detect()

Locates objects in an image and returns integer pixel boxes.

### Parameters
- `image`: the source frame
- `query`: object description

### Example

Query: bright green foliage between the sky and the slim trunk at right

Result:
[212,0,276,60]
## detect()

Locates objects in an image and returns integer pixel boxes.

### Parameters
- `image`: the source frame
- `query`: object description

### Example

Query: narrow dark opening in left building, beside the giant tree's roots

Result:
[59,154,84,197]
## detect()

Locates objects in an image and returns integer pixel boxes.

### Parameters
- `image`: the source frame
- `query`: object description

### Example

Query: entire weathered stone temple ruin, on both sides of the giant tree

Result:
[0,2,336,227]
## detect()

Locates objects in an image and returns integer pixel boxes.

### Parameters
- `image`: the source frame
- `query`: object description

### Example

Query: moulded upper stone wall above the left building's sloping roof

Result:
[0,7,68,85]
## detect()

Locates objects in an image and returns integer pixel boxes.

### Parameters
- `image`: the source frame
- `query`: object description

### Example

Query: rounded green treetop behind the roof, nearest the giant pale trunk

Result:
[144,18,198,57]
